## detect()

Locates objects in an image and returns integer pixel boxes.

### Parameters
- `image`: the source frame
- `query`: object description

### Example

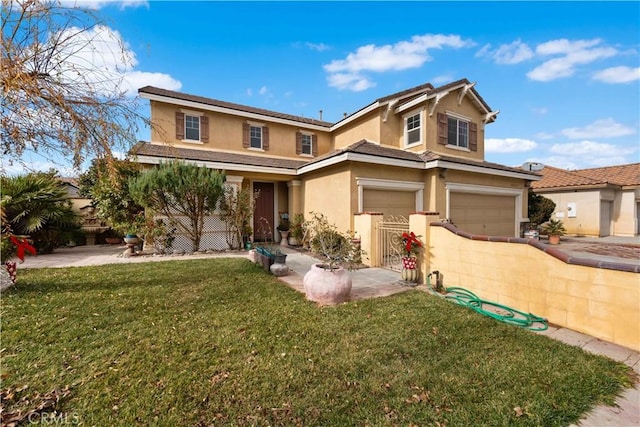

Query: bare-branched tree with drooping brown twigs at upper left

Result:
[0,0,145,171]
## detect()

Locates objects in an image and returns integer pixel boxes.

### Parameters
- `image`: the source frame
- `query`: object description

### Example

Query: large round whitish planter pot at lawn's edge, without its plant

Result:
[302,264,351,305]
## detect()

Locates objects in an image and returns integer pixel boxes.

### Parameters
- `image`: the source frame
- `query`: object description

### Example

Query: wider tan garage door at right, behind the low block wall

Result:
[449,193,516,237]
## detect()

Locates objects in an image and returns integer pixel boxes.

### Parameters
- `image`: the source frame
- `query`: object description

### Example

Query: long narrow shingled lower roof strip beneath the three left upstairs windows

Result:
[131,142,307,170]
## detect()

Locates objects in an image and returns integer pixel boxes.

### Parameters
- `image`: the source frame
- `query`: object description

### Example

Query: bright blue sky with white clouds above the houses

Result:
[7,1,640,174]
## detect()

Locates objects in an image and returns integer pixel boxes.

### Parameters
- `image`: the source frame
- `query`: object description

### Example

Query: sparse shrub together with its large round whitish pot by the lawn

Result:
[302,212,360,305]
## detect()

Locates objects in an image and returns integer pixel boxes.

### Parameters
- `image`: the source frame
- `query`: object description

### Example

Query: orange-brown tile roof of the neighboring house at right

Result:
[531,163,640,189]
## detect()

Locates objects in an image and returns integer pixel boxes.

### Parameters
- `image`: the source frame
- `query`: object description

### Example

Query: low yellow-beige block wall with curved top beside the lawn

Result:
[424,223,640,351]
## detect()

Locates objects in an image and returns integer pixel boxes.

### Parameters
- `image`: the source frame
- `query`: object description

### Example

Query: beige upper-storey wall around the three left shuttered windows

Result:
[151,101,332,160]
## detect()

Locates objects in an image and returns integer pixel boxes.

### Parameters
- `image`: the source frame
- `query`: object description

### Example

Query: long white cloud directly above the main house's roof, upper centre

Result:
[324,34,473,91]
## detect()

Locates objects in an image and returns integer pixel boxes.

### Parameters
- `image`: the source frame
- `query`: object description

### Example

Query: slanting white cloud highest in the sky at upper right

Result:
[527,39,618,82]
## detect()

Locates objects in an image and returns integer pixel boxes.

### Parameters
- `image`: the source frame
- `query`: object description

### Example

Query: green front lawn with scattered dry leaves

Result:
[0,259,631,426]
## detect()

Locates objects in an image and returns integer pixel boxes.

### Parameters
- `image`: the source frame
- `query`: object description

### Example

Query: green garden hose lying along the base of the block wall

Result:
[427,271,549,331]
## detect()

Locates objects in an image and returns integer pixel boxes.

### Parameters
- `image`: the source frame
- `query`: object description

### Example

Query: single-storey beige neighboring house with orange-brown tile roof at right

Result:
[531,163,640,237]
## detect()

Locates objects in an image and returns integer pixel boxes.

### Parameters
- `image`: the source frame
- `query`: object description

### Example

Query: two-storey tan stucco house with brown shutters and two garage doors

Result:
[132,79,540,251]
